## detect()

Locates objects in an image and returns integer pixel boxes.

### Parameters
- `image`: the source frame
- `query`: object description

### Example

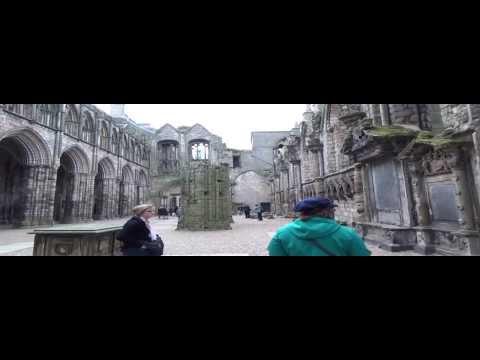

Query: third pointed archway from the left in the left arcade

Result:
[93,158,116,220]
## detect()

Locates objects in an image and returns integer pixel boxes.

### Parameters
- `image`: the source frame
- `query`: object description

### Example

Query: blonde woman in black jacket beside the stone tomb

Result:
[117,204,164,256]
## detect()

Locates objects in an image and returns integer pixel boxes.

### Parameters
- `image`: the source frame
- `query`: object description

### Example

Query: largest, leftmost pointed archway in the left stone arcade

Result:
[0,129,51,226]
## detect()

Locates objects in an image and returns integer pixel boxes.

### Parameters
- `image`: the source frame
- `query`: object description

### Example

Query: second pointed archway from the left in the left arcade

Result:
[53,147,91,224]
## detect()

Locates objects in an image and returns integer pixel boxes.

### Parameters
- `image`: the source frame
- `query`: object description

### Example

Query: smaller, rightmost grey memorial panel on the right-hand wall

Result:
[429,183,458,222]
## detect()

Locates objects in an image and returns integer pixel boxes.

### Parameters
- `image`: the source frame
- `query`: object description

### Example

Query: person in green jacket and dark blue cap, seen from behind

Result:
[268,198,371,256]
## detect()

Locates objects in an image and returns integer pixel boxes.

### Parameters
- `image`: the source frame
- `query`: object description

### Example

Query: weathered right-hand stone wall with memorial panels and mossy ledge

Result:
[272,104,480,255]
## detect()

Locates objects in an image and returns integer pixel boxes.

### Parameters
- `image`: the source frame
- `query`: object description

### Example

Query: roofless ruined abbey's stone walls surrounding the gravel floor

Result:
[0,104,480,255]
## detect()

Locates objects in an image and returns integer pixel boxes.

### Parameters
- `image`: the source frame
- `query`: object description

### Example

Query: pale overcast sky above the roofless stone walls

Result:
[97,104,305,150]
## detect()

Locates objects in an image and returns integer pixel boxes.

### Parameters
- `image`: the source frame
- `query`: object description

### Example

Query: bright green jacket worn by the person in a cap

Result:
[268,217,371,256]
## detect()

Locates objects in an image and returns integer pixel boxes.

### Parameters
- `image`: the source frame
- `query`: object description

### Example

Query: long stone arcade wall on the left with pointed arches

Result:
[0,104,150,226]
